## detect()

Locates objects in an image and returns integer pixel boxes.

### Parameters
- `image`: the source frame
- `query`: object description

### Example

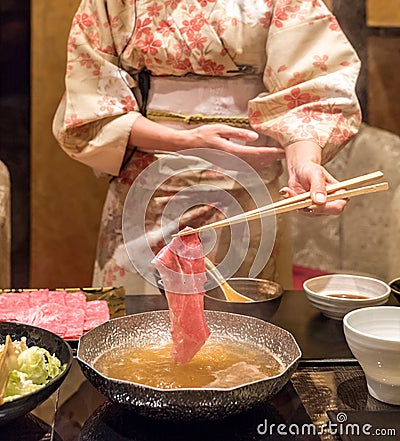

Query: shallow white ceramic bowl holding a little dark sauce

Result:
[303,274,390,320]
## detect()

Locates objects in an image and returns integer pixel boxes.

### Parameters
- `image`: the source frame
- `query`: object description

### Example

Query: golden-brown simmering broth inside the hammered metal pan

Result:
[94,340,284,389]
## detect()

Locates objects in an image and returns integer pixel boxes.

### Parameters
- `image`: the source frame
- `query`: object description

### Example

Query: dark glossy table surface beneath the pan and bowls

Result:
[0,291,400,441]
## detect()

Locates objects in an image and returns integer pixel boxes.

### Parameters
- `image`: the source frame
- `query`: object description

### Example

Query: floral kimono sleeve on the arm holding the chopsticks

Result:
[249,0,361,163]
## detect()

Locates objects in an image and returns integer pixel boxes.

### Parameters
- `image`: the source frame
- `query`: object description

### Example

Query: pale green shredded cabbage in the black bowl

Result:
[4,342,65,402]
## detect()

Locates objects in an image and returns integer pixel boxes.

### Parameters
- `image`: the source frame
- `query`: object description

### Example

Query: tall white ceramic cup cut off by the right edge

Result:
[343,306,400,405]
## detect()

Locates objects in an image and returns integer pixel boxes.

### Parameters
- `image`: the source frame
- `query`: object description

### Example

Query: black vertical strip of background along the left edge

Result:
[0,0,30,287]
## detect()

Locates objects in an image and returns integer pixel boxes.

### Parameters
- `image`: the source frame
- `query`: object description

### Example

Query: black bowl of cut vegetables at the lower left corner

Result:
[0,322,73,424]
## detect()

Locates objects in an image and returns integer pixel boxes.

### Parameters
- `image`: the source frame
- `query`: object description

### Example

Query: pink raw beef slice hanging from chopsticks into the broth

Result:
[153,229,210,364]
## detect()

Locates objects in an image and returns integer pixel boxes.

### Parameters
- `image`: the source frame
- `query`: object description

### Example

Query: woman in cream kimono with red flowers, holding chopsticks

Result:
[53,0,361,293]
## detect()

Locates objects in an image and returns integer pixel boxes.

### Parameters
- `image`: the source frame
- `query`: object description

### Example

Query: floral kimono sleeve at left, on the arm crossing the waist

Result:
[53,0,140,175]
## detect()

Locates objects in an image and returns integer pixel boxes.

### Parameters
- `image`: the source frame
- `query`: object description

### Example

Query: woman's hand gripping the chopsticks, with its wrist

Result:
[281,141,347,217]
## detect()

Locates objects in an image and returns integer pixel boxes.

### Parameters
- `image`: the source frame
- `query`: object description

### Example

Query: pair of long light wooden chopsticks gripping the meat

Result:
[172,171,389,237]
